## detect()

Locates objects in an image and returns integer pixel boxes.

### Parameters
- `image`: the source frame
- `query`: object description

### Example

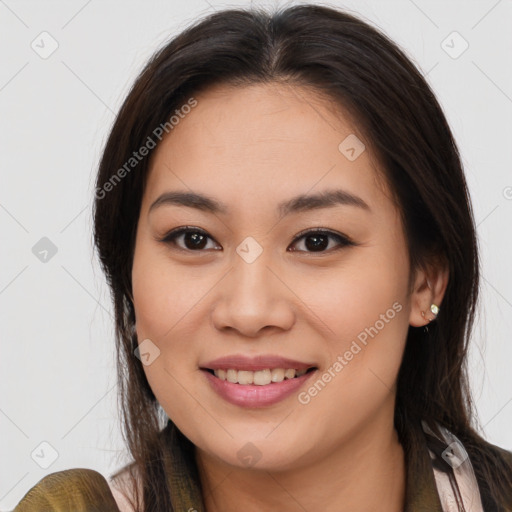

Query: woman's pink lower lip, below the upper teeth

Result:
[203,370,316,408]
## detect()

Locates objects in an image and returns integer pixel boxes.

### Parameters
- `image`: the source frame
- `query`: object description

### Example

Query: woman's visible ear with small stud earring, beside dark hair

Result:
[409,263,449,327]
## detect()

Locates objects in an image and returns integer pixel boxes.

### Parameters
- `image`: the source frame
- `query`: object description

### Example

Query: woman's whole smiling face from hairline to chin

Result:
[132,84,412,469]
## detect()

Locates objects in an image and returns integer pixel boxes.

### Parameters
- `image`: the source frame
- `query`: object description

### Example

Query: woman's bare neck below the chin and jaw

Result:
[196,412,406,512]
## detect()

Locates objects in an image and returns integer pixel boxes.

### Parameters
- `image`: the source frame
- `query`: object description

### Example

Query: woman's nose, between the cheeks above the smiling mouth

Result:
[211,246,295,338]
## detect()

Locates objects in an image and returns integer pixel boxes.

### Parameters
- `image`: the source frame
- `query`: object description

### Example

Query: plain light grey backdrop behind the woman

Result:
[0,0,512,510]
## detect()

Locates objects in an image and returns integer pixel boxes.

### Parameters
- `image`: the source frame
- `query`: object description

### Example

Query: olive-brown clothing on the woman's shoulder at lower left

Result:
[13,468,120,512]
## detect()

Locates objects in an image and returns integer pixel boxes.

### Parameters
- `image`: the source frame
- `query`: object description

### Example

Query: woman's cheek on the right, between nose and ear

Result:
[304,233,409,408]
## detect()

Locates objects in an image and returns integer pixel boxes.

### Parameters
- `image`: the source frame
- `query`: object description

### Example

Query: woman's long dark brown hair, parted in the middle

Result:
[94,4,512,512]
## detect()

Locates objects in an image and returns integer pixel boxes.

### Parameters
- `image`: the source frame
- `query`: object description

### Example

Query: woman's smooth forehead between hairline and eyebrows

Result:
[146,83,392,214]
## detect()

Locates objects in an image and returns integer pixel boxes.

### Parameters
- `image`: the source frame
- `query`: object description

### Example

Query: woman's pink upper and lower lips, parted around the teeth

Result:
[201,355,316,408]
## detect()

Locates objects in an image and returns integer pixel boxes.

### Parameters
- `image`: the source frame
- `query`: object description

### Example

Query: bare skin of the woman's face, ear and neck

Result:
[132,84,448,512]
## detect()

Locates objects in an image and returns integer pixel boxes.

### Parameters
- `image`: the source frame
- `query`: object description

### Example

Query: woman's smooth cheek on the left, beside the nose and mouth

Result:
[132,235,213,412]
